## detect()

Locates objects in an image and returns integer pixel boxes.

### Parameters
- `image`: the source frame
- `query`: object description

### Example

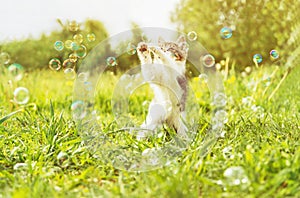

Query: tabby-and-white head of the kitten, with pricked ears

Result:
[158,36,188,62]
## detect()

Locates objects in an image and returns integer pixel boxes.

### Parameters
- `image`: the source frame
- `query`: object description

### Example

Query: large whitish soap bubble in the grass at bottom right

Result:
[223,166,250,187]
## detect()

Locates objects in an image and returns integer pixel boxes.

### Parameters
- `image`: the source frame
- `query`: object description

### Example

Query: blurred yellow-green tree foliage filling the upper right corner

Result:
[171,0,300,69]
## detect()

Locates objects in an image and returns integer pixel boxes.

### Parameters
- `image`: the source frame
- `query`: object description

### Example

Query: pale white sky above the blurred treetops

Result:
[0,0,180,41]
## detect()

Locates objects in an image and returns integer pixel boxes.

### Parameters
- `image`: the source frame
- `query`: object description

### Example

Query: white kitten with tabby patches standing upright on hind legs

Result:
[137,36,188,139]
